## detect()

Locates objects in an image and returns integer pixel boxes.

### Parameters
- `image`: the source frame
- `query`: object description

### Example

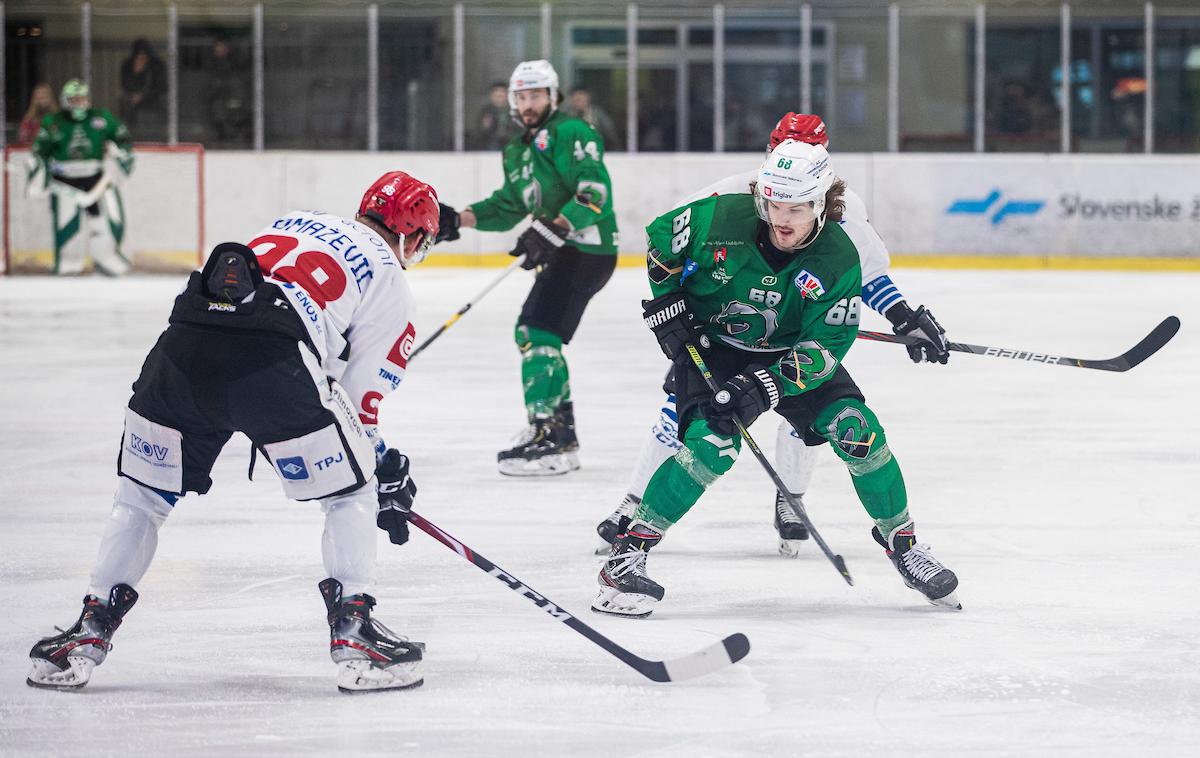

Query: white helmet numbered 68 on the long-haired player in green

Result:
[754,139,838,247]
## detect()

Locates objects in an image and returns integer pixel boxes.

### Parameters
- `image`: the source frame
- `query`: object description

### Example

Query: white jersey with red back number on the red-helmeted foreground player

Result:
[248,211,416,440]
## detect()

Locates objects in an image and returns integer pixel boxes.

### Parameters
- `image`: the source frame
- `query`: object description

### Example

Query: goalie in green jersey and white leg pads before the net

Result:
[29,79,133,276]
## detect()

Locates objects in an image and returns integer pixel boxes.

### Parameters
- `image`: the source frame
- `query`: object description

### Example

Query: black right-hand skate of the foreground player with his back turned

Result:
[317,578,425,692]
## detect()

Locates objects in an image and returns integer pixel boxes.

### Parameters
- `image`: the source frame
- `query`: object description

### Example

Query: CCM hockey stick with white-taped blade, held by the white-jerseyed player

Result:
[408,511,750,681]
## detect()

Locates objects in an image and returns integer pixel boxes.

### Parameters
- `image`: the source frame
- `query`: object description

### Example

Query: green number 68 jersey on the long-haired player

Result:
[646,194,863,395]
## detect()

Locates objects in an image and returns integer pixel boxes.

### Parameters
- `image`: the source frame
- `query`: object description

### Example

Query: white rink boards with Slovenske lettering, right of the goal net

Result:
[205,151,1200,260]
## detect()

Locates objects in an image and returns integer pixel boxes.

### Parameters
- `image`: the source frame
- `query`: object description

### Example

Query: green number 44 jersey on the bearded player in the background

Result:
[470,110,617,255]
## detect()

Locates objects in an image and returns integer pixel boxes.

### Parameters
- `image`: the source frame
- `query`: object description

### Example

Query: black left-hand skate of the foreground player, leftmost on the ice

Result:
[25,584,138,690]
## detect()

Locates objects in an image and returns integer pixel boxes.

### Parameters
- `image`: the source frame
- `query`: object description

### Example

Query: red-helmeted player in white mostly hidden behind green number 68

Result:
[596,113,949,558]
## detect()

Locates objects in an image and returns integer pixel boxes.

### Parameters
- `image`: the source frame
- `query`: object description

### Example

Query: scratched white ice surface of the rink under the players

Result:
[0,269,1200,757]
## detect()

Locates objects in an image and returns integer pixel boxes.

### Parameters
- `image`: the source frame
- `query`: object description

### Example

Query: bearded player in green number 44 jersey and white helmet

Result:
[438,60,617,476]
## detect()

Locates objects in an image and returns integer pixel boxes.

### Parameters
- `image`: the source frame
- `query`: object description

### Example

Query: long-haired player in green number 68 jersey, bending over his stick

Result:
[592,139,959,616]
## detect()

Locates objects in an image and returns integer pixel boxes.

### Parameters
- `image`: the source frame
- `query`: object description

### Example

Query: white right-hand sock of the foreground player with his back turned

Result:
[320,480,379,597]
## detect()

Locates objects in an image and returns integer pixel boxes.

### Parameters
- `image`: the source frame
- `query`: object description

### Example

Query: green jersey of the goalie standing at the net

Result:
[34,108,133,179]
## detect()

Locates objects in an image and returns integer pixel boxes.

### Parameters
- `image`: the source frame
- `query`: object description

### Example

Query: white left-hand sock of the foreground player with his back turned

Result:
[88,476,172,603]
